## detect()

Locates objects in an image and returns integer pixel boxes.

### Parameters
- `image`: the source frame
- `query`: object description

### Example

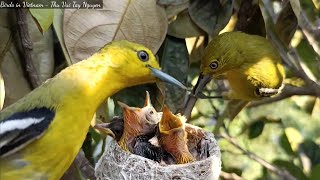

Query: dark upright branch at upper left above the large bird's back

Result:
[15,3,41,88]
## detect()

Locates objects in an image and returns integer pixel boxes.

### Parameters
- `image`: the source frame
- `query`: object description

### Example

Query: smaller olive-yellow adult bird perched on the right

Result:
[195,32,285,132]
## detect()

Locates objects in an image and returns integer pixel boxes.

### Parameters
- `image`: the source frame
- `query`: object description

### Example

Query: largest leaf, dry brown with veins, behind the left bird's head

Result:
[63,0,167,63]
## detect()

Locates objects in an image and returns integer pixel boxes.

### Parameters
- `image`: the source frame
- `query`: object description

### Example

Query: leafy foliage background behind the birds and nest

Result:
[0,0,320,179]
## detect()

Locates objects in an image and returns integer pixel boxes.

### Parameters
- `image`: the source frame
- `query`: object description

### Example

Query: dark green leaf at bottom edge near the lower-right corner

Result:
[272,159,308,180]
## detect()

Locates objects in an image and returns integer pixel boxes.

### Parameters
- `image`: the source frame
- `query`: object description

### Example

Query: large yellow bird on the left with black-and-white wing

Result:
[0,41,185,180]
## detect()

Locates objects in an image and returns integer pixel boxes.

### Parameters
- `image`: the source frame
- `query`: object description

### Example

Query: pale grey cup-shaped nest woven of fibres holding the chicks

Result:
[95,133,221,180]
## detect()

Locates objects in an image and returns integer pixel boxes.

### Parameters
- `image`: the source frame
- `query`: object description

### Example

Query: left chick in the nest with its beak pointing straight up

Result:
[94,91,161,155]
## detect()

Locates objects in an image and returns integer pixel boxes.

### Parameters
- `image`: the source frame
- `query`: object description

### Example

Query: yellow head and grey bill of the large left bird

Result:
[97,40,186,89]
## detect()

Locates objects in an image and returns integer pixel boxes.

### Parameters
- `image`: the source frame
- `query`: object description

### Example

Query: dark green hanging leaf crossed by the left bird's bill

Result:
[158,36,189,112]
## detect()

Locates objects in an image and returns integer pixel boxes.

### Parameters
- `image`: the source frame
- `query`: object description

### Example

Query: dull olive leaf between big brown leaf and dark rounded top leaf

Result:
[168,11,205,38]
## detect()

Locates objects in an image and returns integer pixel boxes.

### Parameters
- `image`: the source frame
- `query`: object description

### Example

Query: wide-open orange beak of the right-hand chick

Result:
[159,106,183,133]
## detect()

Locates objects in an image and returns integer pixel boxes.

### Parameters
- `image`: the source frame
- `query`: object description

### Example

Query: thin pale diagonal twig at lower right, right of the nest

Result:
[220,132,295,180]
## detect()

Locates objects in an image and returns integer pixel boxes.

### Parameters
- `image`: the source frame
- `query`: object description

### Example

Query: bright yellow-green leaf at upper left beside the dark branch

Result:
[29,8,53,33]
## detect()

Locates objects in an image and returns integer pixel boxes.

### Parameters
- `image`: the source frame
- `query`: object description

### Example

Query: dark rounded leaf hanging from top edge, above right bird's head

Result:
[189,0,233,35]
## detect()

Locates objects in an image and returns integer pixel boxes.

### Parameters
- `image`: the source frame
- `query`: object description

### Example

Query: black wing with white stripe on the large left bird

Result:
[0,107,55,157]
